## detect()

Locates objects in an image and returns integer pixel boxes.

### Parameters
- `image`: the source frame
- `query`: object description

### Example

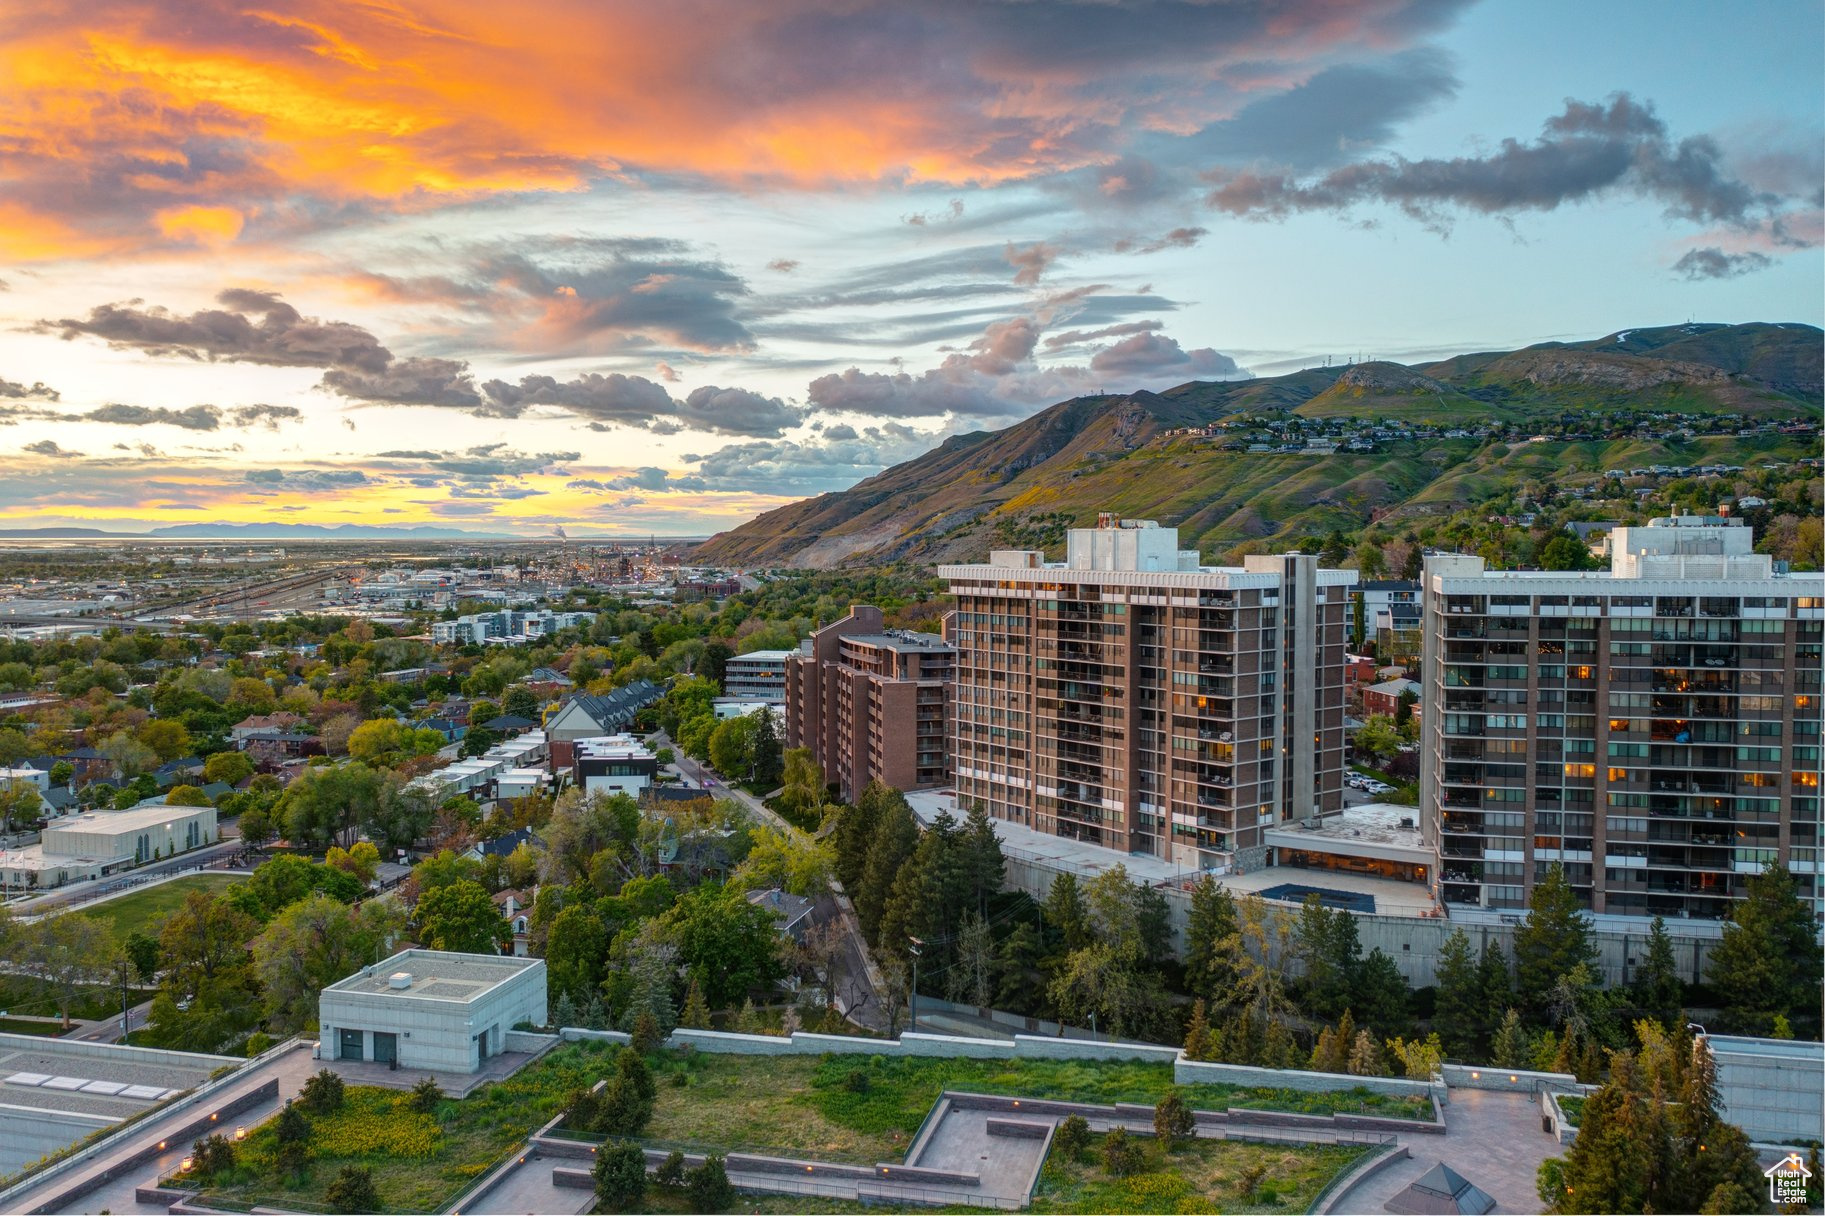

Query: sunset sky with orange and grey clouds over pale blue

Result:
[0,0,1825,535]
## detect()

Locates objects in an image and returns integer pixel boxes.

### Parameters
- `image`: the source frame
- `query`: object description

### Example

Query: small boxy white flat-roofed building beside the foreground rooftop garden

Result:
[318,949,546,1072]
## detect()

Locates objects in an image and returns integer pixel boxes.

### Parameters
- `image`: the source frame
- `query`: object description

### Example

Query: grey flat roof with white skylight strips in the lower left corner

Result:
[0,1035,231,1119]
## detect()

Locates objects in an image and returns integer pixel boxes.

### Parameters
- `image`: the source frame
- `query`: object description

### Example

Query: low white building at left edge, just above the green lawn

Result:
[0,805,221,891]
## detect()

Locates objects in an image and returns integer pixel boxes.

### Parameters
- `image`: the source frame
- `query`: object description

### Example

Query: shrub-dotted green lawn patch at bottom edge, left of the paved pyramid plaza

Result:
[1031,1136,1369,1212]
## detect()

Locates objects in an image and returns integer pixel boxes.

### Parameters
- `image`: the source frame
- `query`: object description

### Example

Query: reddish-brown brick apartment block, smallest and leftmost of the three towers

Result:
[785,604,954,802]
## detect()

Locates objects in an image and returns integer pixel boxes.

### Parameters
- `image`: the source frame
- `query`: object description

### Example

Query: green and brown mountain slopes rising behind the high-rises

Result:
[697,323,1825,568]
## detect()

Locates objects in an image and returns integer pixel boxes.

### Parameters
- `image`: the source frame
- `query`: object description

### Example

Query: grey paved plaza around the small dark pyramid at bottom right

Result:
[1330,1090,1559,1212]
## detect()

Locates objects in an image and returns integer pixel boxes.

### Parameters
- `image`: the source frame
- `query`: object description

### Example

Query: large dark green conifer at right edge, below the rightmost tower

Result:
[1708,862,1820,1033]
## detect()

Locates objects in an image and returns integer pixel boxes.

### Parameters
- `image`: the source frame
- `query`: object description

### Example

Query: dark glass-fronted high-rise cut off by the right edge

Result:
[1420,515,1825,920]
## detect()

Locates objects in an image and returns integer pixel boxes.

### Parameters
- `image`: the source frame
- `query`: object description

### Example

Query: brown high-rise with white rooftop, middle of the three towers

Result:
[938,515,1356,871]
